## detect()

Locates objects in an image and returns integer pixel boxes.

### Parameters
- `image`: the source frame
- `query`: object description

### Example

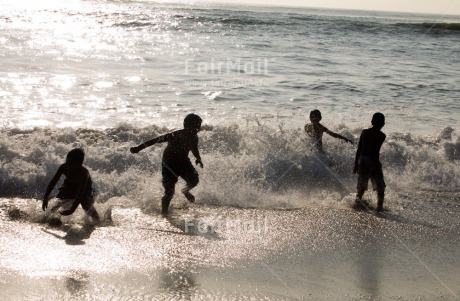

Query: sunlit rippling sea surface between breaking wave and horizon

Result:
[0,0,460,135]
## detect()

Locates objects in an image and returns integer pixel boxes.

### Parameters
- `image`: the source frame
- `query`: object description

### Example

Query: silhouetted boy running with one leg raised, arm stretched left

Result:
[130,114,203,215]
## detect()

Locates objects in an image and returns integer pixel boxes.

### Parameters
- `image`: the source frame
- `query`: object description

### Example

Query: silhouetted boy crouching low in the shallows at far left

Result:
[42,148,99,221]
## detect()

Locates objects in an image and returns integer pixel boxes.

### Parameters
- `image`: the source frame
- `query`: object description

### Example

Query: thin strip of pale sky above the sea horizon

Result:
[206,0,460,15]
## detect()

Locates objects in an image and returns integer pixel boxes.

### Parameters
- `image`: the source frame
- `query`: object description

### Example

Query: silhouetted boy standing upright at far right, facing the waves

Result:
[353,113,386,212]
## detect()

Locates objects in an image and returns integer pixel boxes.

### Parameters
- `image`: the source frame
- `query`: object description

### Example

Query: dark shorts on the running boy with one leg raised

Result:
[161,160,198,186]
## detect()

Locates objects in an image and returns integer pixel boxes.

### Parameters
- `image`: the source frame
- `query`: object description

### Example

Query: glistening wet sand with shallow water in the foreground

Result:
[0,199,460,300]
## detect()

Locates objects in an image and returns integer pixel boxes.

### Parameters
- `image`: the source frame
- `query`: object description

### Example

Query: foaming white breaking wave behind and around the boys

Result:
[0,124,460,208]
